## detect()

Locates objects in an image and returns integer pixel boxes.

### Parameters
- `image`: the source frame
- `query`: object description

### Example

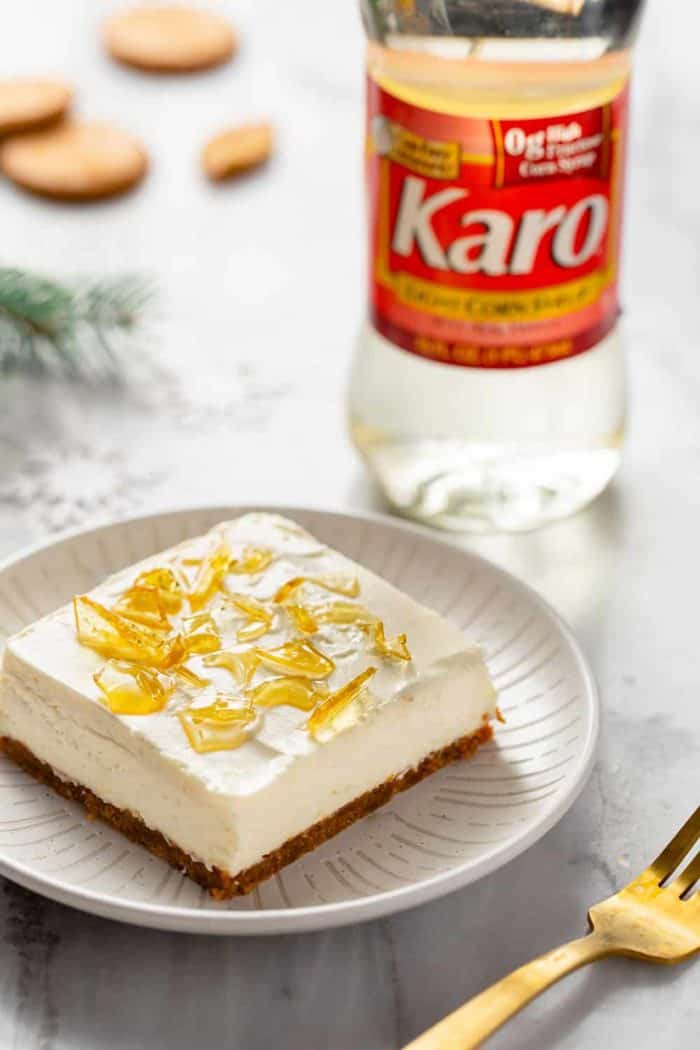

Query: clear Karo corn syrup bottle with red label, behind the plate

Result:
[349,0,642,530]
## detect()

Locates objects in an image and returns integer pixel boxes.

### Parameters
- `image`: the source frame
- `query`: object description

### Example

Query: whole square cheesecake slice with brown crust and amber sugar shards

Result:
[0,513,496,898]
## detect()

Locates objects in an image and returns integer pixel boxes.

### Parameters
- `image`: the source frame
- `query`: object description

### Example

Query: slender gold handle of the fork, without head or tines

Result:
[404,931,611,1050]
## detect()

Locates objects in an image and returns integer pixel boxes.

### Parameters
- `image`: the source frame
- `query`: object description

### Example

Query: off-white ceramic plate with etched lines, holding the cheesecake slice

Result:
[0,506,598,935]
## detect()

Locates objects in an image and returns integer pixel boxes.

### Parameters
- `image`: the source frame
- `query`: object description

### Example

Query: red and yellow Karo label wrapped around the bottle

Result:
[367,79,628,369]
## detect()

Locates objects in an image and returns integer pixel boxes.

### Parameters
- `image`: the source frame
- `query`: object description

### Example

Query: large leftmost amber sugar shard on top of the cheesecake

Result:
[73,595,185,670]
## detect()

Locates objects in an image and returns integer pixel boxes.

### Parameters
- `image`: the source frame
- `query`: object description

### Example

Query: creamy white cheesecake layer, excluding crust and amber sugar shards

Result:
[0,515,495,874]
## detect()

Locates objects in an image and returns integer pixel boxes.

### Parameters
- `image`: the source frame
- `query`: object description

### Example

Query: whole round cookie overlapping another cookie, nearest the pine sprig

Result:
[0,121,148,201]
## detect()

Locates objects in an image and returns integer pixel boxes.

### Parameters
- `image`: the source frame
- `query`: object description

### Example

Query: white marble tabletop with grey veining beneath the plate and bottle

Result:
[0,0,700,1050]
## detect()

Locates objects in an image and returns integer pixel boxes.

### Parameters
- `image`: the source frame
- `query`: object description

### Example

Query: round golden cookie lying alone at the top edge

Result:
[103,6,237,72]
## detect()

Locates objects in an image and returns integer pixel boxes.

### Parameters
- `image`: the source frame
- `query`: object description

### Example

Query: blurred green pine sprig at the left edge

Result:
[0,267,154,382]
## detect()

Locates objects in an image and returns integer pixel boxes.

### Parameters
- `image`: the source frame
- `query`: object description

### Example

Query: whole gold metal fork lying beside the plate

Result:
[404,807,700,1050]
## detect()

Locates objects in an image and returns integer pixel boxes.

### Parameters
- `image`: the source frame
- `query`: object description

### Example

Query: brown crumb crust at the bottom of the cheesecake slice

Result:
[0,721,493,900]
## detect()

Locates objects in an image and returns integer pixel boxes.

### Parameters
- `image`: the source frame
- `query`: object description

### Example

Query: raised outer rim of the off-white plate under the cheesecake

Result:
[0,501,600,937]
